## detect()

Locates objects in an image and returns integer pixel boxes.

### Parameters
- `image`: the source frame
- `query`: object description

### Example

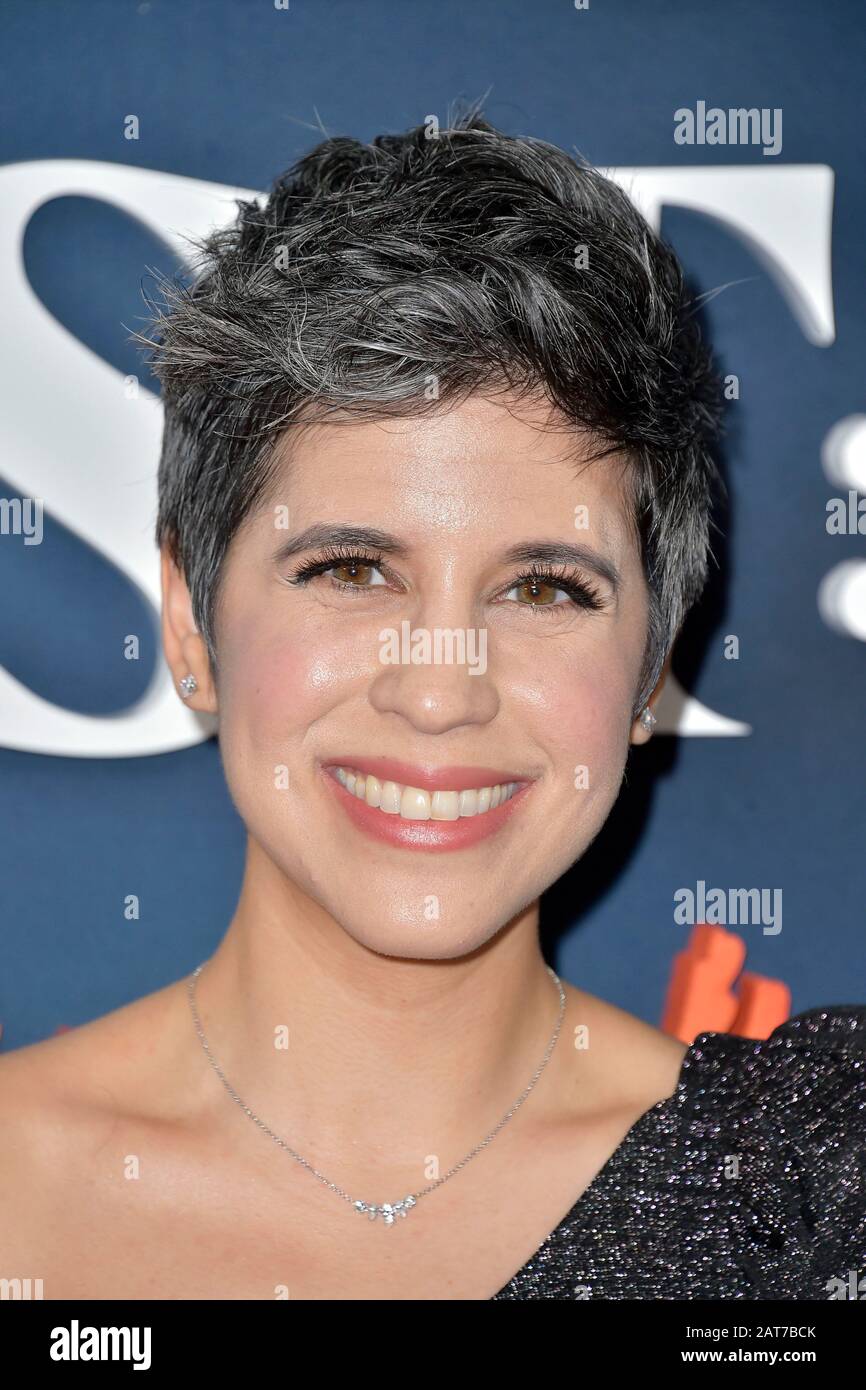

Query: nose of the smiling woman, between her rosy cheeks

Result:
[370,619,499,734]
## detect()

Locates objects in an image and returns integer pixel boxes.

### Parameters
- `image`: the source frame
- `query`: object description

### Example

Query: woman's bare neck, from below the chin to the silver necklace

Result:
[189,845,566,1186]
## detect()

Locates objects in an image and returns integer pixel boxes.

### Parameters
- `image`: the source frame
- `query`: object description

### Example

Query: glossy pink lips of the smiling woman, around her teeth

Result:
[321,755,532,852]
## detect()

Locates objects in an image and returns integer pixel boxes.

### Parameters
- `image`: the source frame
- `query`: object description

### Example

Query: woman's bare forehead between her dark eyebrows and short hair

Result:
[265,396,631,549]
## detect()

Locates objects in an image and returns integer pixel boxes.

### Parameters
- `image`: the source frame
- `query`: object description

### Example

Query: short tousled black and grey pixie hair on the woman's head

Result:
[140,106,724,716]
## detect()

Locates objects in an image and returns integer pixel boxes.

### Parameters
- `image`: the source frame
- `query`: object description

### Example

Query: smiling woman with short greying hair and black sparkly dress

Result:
[0,111,866,1300]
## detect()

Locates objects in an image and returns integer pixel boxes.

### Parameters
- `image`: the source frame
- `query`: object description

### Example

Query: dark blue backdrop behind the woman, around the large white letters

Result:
[0,0,866,1048]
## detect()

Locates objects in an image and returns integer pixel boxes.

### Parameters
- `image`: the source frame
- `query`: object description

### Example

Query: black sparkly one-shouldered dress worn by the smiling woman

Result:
[492,1004,866,1301]
